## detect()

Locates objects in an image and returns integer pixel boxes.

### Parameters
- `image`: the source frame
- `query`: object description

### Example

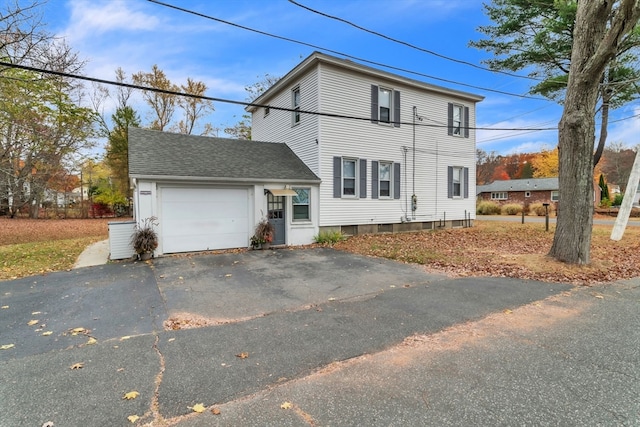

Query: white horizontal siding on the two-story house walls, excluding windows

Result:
[253,62,476,231]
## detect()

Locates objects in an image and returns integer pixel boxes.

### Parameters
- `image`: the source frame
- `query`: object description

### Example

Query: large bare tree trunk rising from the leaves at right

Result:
[549,0,640,264]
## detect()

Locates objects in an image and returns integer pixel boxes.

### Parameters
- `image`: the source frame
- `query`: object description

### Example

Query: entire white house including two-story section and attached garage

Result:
[129,52,483,255]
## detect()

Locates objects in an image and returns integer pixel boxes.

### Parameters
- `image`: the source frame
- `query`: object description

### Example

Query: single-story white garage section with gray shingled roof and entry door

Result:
[129,128,320,255]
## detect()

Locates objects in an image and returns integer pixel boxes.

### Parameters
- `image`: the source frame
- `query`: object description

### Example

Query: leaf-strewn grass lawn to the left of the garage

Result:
[0,217,113,280]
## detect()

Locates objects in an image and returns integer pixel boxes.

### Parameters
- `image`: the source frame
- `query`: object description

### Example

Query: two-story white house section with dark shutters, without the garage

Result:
[247,52,483,234]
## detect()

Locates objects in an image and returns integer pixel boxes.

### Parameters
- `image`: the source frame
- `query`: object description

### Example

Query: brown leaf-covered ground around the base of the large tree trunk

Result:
[334,220,640,285]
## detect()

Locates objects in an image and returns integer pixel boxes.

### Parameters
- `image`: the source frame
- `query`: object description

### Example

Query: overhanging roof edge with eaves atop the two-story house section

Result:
[245,52,484,112]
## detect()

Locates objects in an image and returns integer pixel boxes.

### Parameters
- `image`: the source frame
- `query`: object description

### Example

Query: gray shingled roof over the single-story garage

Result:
[129,128,320,182]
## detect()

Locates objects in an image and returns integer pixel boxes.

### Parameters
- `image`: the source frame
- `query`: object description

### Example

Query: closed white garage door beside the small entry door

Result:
[160,187,249,253]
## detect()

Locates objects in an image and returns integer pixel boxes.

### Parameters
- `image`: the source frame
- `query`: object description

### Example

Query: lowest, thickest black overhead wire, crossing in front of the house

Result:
[0,61,557,131]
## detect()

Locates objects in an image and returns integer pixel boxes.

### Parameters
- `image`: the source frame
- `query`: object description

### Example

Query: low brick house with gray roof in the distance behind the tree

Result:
[476,178,560,207]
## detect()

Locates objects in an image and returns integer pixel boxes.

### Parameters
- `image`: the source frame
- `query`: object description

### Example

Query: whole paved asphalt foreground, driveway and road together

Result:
[0,249,640,427]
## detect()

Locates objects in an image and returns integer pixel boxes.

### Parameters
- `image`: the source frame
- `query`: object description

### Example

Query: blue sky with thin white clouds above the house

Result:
[43,0,640,154]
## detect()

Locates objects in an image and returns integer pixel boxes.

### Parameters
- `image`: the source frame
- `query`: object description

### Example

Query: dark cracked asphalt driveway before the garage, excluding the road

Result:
[0,248,570,426]
